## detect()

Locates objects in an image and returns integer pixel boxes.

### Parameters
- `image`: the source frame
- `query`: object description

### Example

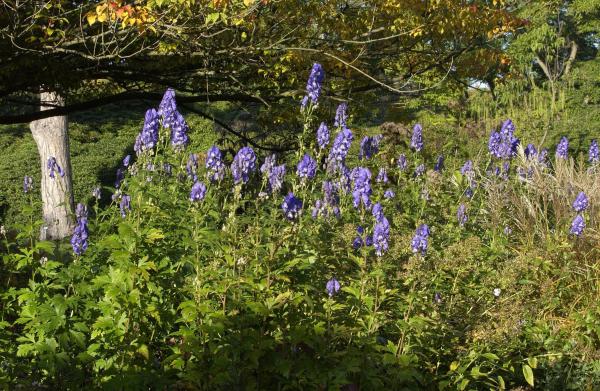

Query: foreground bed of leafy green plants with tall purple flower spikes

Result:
[0,69,600,390]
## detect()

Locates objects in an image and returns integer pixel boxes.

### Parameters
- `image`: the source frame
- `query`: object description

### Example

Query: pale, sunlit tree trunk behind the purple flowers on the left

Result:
[30,92,74,240]
